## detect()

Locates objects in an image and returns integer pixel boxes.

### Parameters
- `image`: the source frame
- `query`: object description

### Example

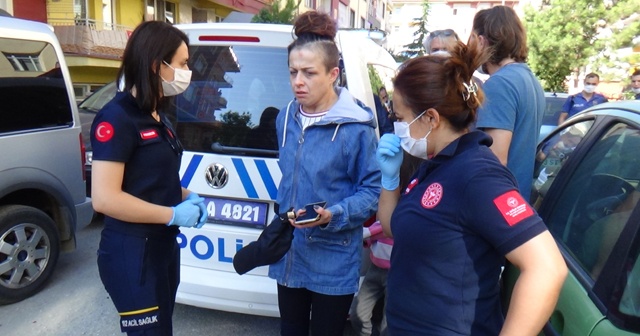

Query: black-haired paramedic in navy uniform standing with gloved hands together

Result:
[91,21,207,335]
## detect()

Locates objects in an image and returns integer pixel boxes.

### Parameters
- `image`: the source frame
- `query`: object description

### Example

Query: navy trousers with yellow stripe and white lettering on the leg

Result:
[98,229,180,336]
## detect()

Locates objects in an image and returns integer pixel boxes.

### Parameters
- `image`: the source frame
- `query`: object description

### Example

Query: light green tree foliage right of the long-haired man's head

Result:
[524,0,640,91]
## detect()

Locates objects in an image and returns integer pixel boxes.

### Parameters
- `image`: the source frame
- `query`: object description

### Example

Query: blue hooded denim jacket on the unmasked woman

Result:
[269,88,380,295]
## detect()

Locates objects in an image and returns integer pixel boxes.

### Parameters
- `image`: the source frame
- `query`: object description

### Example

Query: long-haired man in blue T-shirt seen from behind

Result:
[471,6,546,201]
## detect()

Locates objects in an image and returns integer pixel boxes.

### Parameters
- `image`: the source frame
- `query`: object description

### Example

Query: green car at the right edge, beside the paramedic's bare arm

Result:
[504,101,640,336]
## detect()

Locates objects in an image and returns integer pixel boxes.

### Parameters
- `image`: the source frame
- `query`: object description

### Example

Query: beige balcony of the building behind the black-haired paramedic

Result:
[49,19,132,60]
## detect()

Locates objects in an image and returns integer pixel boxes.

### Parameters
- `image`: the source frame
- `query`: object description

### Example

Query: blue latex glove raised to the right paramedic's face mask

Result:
[376,133,402,190]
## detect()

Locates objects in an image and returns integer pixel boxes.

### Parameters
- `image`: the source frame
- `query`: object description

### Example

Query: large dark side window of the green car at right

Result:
[547,123,640,280]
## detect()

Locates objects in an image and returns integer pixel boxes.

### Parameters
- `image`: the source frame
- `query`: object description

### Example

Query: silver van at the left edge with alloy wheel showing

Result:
[0,17,93,304]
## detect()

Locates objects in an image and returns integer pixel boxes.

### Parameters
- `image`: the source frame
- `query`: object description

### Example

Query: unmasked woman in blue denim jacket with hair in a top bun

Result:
[269,11,380,336]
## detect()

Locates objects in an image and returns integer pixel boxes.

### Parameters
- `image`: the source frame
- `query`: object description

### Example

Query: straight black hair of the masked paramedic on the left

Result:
[118,21,189,113]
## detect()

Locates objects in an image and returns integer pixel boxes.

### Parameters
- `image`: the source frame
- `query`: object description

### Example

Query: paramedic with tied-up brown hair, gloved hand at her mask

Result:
[376,39,567,336]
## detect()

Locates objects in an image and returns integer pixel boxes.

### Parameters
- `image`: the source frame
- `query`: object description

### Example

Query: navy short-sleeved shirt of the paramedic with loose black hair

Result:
[91,92,182,236]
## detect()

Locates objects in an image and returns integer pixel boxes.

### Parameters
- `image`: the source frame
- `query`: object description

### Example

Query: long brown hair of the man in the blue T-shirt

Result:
[473,6,529,64]
